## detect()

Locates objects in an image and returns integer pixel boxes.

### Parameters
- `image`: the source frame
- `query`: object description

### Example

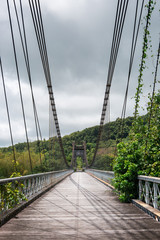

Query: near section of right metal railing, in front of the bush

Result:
[138,175,160,210]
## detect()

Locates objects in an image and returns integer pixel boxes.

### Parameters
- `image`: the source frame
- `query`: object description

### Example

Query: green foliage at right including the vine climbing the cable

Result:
[114,1,160,202]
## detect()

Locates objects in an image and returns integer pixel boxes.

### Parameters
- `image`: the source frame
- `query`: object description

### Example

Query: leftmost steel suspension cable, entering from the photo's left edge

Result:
[0,57,17,171]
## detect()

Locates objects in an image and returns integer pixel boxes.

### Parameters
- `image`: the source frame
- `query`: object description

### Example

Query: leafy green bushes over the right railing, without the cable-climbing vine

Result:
[114,95,160,202]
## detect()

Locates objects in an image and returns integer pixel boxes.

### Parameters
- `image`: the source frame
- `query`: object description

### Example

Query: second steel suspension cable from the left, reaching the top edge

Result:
[7,0,33,172]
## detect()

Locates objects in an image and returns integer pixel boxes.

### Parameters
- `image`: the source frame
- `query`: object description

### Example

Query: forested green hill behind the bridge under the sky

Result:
[0,116,145,178]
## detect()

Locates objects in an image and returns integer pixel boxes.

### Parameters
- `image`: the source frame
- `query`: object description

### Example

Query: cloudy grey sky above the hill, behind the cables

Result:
[0,0,160,146]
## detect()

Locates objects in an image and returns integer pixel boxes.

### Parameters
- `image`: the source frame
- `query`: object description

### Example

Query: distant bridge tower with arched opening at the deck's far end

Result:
[72,141,88,168]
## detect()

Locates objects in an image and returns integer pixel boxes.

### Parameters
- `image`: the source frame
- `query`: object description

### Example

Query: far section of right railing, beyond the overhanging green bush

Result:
[85,169,114,184]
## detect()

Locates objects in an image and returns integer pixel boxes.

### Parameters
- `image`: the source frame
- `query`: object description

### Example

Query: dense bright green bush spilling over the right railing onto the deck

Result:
[114,140,141,202]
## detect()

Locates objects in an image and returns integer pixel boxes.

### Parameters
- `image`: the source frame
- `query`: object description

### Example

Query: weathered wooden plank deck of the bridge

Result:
[0,172,160,240]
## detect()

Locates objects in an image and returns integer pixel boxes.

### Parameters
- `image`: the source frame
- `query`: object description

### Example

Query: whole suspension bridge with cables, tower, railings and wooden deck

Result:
[0,0,160,240]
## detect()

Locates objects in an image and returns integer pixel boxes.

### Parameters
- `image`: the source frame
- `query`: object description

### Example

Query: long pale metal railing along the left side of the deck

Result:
[0,170,73,214]
